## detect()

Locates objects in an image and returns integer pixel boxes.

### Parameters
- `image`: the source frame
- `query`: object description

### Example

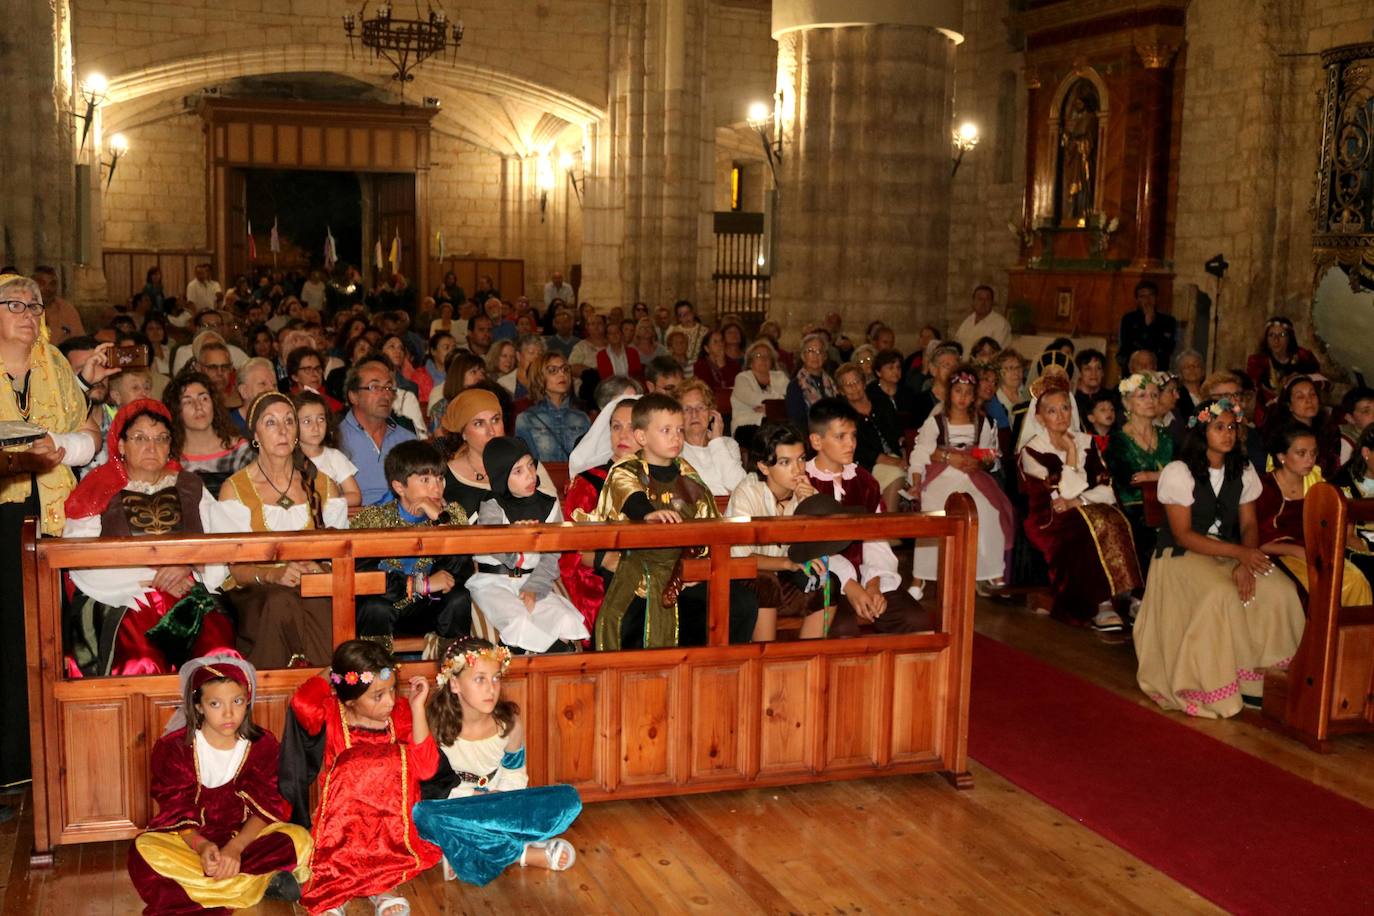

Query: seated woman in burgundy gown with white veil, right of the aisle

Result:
[1018,372,1142,632]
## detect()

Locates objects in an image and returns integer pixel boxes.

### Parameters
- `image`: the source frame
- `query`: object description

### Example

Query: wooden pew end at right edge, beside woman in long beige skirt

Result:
[1260,483,1374,754]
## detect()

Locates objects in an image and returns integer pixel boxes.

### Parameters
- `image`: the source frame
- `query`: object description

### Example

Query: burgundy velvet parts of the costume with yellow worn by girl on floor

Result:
[129,728,297,916]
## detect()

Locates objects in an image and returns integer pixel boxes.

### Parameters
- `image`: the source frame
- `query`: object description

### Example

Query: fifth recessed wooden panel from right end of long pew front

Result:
[618,669,682,786]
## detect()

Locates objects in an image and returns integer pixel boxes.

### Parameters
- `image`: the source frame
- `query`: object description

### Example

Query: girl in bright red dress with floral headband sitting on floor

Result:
[280,640,441,916]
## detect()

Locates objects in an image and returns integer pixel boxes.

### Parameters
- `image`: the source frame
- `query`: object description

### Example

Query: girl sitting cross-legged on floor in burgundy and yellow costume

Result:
[129,655,311,916]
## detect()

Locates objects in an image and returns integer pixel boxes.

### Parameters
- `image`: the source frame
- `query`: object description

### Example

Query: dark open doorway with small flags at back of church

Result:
[243,169,364,268]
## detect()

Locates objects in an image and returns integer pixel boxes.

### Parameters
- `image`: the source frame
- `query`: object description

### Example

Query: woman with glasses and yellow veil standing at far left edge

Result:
[0,273,113,791]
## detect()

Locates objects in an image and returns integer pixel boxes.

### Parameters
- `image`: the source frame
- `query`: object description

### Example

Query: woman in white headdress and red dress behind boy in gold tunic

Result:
[558,394,639,630]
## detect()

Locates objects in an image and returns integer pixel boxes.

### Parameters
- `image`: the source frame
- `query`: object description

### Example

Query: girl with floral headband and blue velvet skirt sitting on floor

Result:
[415,639,583,886]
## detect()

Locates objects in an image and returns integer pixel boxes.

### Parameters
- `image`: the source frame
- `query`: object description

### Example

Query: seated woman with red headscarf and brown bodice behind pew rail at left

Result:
[62,398,234,676]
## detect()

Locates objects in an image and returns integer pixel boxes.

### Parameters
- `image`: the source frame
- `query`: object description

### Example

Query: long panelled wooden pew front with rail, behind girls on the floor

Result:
[22,494,977,864]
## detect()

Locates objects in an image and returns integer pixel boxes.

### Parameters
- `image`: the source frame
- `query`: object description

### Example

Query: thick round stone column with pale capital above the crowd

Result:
[769,0,962,339]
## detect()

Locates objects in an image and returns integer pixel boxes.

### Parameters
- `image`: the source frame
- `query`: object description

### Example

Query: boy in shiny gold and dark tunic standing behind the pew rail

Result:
[592,393,758,650]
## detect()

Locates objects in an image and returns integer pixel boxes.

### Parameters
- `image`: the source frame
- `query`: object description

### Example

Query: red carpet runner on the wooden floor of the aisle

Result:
[969,636,1374,913]
